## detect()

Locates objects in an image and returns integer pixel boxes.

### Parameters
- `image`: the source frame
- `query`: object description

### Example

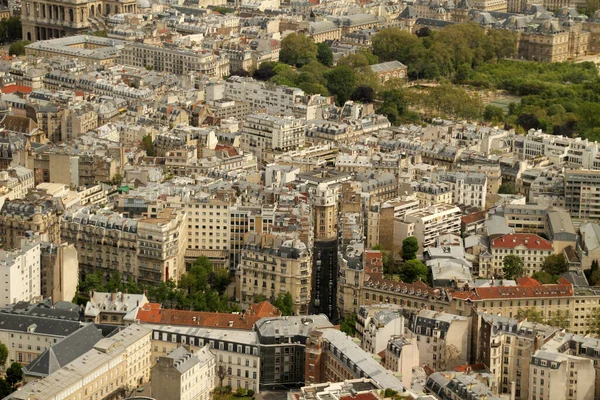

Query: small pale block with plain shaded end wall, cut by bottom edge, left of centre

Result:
[152,345,216,400]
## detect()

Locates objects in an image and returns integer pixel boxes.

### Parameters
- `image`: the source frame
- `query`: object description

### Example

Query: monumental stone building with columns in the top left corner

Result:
[21,0,137,42]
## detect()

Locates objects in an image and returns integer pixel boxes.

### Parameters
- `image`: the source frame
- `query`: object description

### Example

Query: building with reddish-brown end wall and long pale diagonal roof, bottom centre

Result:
[306,328,406,394]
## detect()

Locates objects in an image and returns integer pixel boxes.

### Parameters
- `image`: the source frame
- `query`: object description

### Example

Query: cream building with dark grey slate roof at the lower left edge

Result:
[0,313,81,365]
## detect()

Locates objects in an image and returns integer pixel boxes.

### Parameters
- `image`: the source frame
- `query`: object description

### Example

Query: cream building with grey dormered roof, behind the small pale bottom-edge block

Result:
[151,325,262,393]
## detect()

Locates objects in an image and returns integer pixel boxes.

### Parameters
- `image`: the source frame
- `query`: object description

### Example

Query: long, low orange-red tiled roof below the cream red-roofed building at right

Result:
[450,279,573,301]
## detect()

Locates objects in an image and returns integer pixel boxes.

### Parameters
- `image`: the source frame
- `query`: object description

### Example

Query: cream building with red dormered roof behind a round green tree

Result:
[479,233,554,278]
